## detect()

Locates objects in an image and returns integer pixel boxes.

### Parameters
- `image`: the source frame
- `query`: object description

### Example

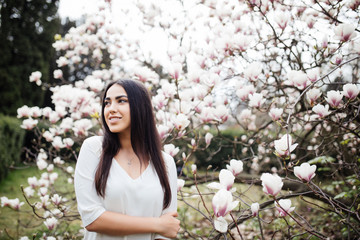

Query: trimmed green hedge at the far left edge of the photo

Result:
[0,115,25,180]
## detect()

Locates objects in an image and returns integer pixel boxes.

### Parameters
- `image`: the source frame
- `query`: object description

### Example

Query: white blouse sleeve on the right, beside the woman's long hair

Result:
[155,153,177,239]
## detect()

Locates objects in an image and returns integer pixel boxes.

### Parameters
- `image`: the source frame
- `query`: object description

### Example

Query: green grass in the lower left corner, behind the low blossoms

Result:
[0,167,81,239]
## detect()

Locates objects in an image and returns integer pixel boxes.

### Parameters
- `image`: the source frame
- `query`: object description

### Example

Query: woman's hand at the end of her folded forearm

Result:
[158,212,180,238]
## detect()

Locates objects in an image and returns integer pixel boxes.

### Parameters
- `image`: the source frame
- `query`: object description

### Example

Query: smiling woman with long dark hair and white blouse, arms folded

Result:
[75,80,180,240]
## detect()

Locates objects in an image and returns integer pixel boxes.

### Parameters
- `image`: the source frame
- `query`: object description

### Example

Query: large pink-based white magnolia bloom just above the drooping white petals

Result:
[212,189,239,217]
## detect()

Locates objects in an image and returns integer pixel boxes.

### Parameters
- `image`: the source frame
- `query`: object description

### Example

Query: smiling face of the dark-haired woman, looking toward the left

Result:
[104,84,131,133]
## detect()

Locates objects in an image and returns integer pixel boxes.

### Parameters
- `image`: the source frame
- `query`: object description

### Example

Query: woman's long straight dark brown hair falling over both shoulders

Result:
[95,79,171,209]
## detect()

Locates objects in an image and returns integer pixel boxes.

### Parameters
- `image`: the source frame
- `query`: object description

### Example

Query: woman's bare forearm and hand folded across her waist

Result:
[86,211,180,238]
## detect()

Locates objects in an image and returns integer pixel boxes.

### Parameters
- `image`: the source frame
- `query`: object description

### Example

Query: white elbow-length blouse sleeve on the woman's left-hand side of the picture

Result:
[74,137,105,227]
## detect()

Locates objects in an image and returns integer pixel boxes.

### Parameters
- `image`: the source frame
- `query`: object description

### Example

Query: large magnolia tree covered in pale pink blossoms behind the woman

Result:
[1,0,360,239]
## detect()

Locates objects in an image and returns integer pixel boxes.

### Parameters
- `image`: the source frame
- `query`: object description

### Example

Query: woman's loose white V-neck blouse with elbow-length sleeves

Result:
[74,136,177,240]
